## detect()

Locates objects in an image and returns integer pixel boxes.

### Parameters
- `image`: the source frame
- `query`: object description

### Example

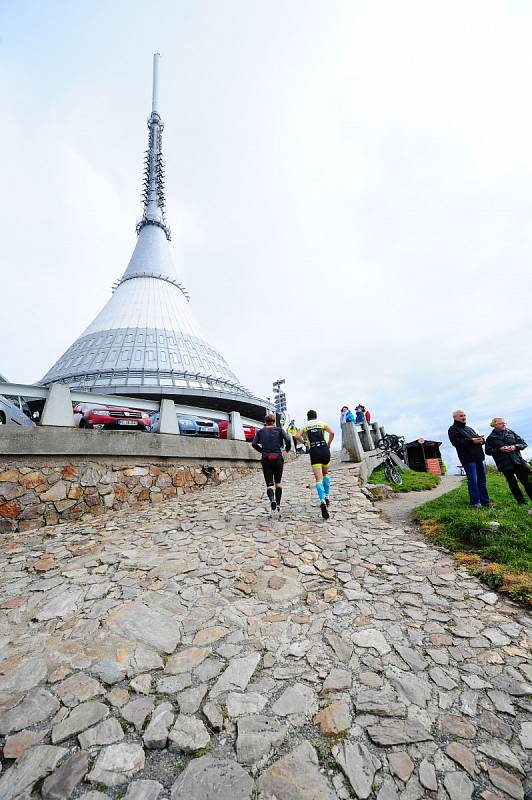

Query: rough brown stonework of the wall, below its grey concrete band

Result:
[0,457,258,533]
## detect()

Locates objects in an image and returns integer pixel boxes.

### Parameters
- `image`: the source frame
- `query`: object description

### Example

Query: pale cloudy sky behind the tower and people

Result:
[0,0,532,462]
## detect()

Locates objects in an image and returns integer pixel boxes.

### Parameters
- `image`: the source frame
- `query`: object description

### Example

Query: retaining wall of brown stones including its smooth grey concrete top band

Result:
[0,425,259,534]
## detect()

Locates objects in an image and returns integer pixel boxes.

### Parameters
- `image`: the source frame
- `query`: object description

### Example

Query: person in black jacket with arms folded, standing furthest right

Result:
[486,417,532,506]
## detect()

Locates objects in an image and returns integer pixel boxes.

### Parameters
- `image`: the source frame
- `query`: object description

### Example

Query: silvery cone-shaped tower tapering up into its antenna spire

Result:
[41,53,269,417]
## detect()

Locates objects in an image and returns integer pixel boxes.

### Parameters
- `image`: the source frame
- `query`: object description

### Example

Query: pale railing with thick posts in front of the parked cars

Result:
[0,382,262,440]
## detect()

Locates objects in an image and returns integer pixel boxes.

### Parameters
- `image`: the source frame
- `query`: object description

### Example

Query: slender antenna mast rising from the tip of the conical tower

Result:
[137,53,170,239]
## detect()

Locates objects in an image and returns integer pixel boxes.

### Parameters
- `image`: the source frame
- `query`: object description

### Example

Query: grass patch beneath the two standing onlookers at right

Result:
[415,472,532,605]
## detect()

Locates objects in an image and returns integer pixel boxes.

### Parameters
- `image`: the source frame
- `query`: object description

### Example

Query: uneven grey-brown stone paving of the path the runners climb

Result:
[0,457,532,800]
